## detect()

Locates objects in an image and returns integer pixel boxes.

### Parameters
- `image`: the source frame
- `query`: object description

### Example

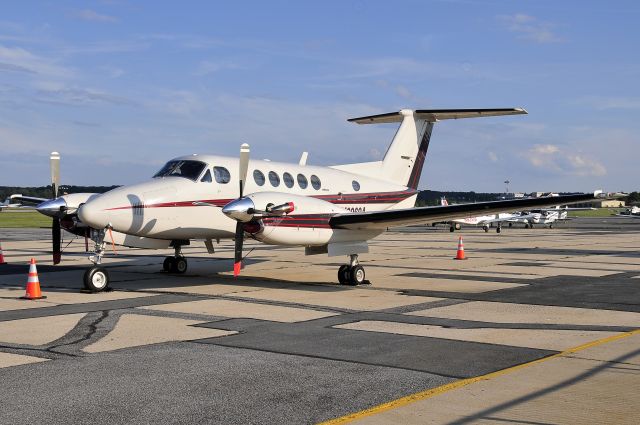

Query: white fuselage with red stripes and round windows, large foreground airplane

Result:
[79,155,417,245]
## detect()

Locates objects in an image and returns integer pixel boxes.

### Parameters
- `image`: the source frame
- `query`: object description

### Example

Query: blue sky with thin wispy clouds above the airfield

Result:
[0,0,640,192]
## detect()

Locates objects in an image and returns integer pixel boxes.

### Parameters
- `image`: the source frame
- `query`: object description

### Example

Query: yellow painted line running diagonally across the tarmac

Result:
[318,329,640,425]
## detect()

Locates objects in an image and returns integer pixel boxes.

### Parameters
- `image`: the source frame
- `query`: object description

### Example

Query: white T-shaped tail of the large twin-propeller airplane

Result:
[333,108,527,189]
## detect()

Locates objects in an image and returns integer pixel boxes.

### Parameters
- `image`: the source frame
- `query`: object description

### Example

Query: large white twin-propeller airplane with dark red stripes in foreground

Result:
[33,108,598,291]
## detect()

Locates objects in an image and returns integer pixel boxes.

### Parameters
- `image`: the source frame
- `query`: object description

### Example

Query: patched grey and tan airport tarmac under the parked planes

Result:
[0,218,640,424]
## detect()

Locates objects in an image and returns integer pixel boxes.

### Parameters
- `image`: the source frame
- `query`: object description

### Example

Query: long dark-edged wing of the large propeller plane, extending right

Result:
[329,191,603,230]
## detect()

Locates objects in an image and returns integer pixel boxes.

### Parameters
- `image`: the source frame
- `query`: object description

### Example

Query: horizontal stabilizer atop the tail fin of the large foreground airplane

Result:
[348,108,527,124]
